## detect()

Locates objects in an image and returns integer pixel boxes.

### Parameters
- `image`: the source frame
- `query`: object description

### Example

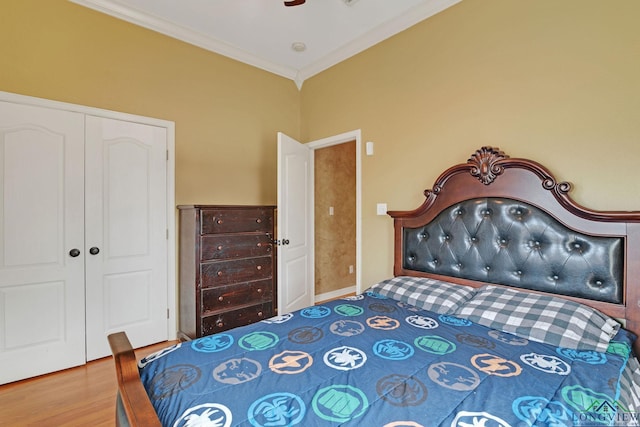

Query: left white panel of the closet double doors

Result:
[0,102,85,383]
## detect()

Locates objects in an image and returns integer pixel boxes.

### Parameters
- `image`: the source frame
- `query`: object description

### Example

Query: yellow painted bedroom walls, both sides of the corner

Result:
[0,0,640,287]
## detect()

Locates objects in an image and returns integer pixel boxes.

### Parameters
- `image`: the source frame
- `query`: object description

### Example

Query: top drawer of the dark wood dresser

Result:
[202,209,273,234]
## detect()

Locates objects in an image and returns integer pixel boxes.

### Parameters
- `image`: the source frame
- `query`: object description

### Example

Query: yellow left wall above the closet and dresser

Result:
[0,0,300,204]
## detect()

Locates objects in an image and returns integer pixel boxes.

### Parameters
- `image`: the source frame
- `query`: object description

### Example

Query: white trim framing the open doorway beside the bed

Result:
[307,129,363,294]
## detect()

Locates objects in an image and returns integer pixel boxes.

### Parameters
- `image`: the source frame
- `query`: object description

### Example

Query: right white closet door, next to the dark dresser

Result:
[85,116,168,360]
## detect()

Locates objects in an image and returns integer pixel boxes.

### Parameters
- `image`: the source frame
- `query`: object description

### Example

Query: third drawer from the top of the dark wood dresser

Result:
[200,257,273,289]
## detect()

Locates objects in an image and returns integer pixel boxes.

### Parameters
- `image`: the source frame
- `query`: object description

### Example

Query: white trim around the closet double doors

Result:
[0,91,178,340]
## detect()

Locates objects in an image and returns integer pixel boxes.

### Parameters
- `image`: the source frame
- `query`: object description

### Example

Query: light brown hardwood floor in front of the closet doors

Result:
[0,342,173,427]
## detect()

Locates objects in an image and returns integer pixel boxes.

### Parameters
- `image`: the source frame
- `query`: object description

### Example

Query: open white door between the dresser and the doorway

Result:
[277,132,315,314]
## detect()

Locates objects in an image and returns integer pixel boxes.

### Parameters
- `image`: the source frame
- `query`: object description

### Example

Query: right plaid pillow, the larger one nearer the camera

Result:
[455,286,620,353]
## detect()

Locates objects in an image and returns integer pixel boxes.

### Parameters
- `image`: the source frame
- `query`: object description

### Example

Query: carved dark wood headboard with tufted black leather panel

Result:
[388,147,640,354]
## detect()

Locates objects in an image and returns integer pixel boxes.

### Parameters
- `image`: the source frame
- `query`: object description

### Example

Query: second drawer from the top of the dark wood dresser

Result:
[200,233,273,261]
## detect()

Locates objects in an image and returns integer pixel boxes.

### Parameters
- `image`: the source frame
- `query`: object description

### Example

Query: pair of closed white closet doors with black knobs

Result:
[0,102,167,384]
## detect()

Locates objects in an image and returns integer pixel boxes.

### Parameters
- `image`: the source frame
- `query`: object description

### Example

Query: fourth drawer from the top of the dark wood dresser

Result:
[202,279,273,315]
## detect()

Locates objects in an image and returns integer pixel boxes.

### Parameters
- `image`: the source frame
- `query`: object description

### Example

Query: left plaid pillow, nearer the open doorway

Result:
[370,276,475,314]
